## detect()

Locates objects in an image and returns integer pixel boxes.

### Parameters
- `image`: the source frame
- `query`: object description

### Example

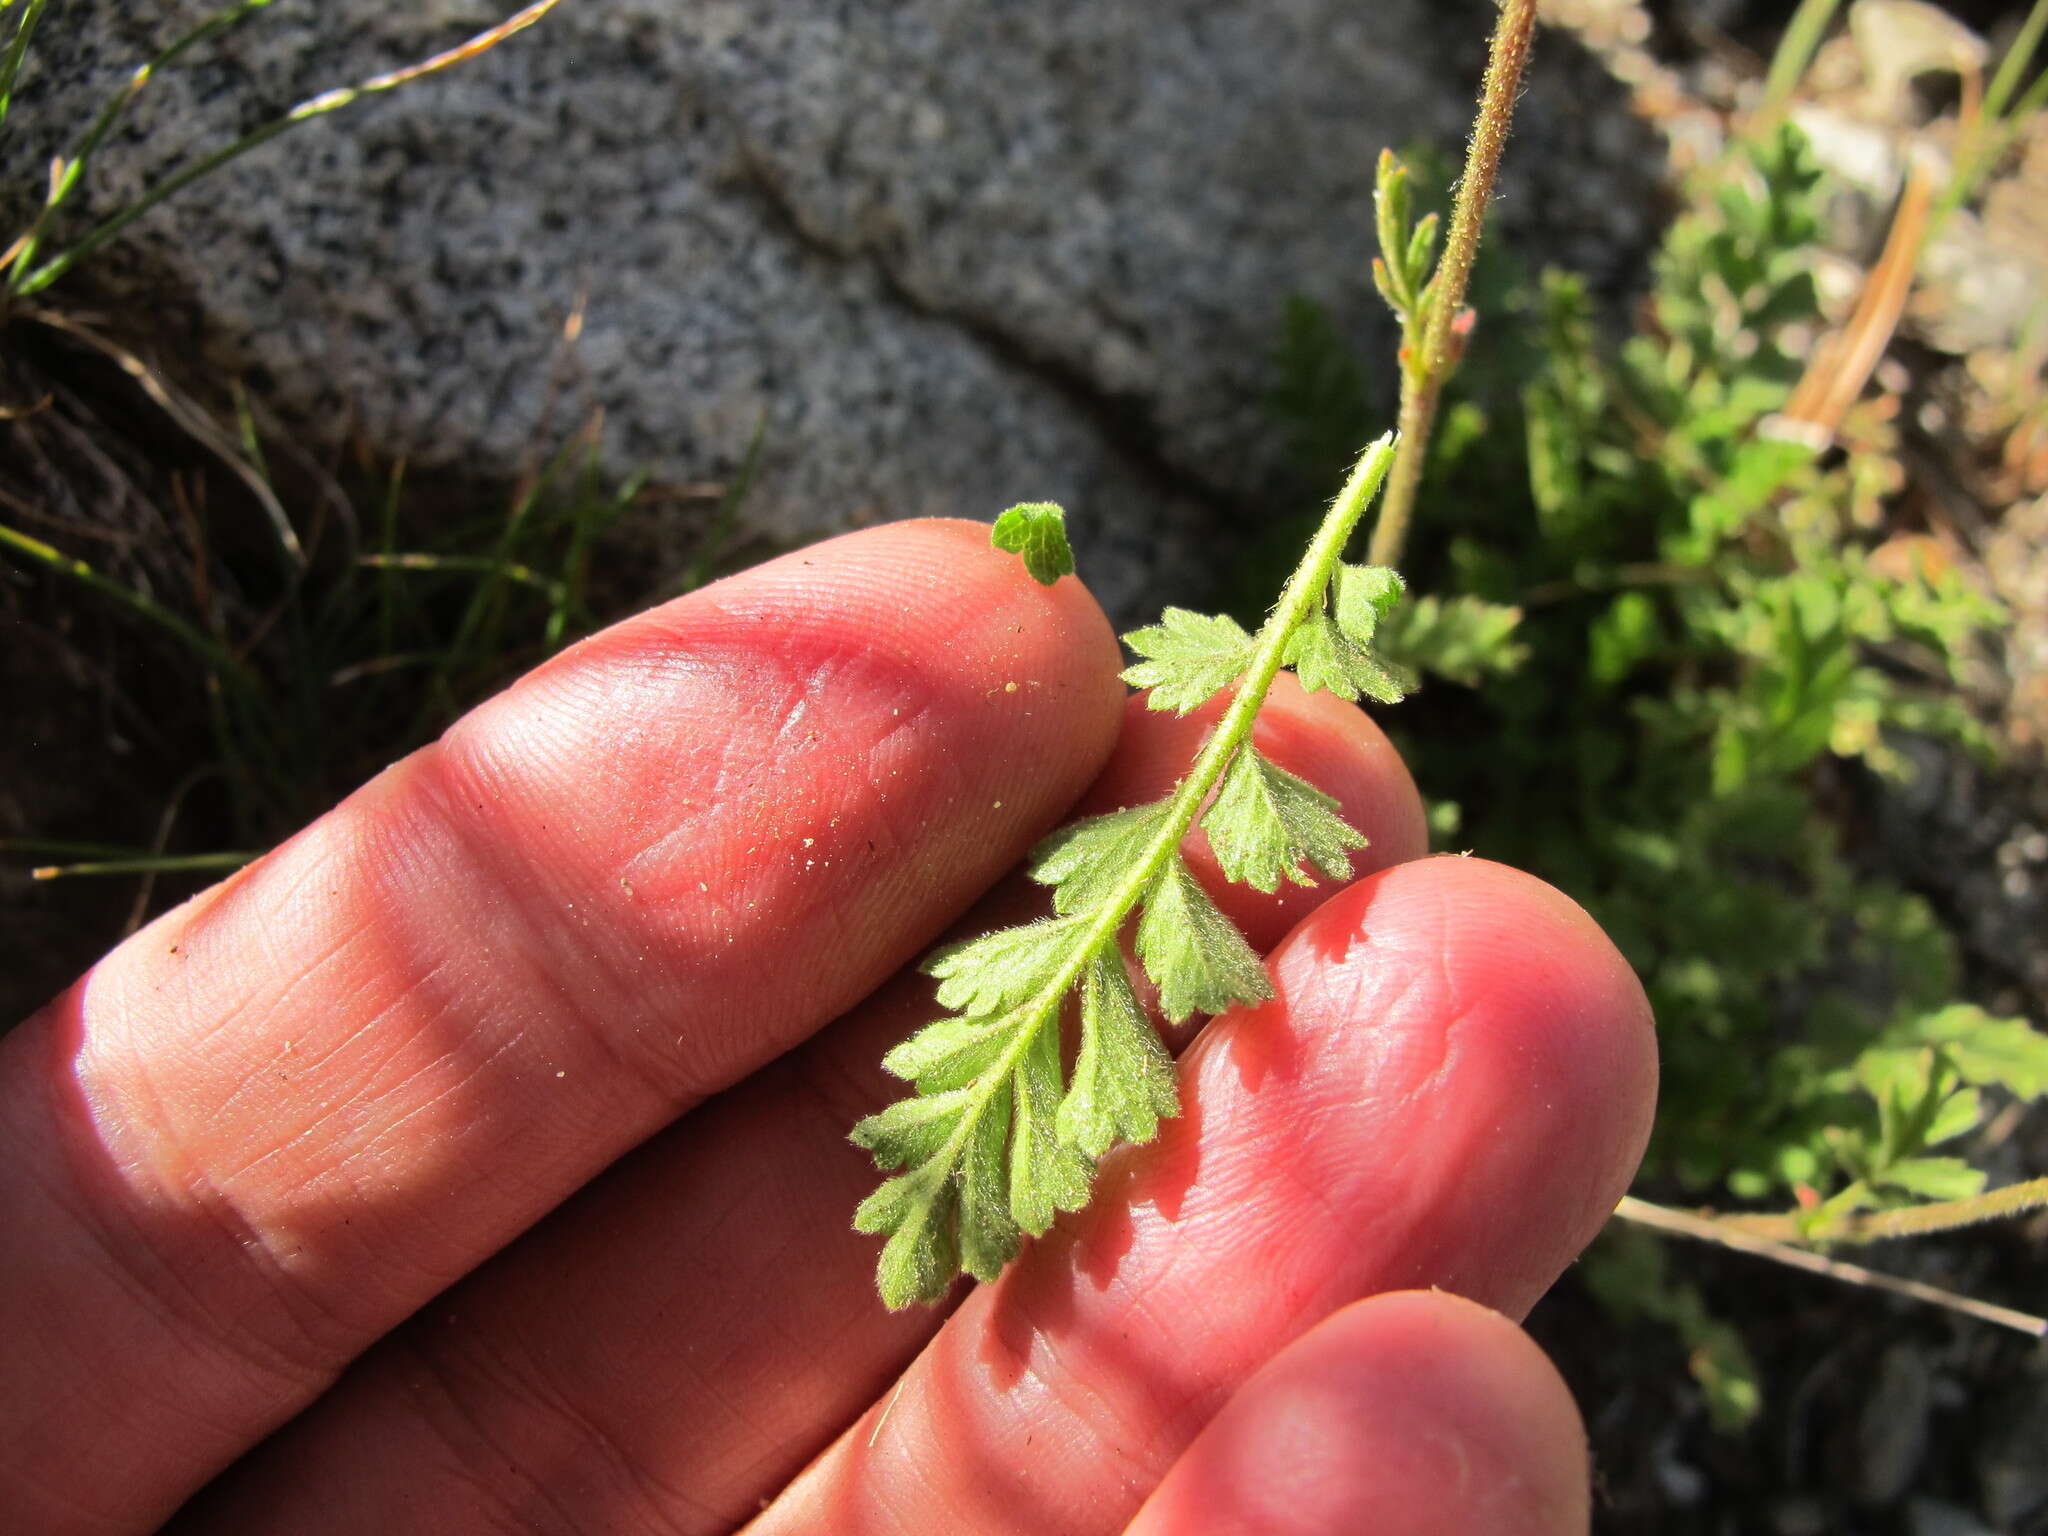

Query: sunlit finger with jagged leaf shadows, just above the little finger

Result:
[760,858,1655,1536]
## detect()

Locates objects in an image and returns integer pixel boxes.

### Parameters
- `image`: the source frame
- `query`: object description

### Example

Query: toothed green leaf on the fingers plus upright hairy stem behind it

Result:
[852,0,1534,1307]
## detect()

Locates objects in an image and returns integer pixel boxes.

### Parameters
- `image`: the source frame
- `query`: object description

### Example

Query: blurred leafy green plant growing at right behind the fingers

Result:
[1276,90,2048,1425]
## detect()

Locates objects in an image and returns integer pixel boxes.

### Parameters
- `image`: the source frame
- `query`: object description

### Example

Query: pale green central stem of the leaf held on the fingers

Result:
[926,434,1397,1169]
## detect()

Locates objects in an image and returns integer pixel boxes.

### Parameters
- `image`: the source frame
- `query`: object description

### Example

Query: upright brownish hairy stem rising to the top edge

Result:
[1366,0,1536,565]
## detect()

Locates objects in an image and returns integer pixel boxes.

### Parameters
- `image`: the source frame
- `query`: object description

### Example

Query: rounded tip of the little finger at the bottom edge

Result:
[1126,1290,1591,1536]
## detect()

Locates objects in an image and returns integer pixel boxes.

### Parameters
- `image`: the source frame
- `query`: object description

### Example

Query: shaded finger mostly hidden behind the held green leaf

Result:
[180,688,1421,1536]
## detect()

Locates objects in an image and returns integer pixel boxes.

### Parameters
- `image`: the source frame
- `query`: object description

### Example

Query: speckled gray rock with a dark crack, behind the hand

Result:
[4,0,1659,606]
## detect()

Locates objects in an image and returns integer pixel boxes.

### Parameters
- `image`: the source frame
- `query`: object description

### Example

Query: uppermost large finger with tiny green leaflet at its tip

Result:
[0,522,1122,1530]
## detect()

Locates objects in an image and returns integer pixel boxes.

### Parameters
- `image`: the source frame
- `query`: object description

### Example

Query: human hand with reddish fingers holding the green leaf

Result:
[0,522,1655,1536]
